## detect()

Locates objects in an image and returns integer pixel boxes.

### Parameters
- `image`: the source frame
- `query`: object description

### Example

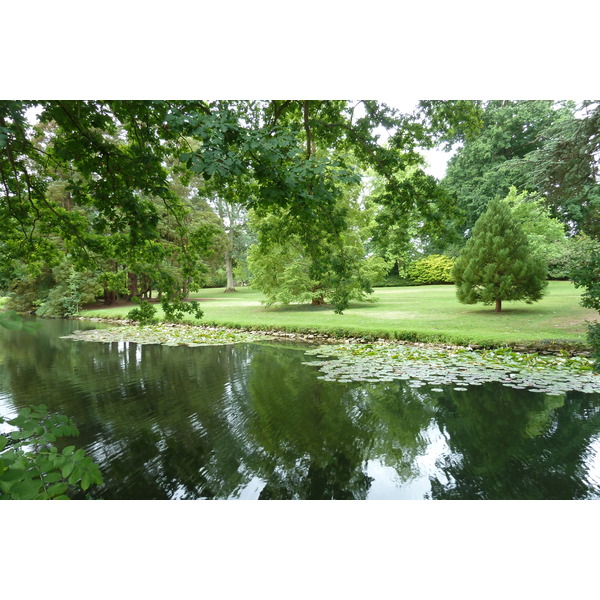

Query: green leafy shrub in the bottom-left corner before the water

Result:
[0,404,102,500]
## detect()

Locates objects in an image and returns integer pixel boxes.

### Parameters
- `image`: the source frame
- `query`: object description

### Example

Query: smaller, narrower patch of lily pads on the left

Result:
[62,324,264,347]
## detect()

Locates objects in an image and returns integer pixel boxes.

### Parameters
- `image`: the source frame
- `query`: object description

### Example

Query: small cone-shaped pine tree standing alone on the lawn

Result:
[453,200,548,312]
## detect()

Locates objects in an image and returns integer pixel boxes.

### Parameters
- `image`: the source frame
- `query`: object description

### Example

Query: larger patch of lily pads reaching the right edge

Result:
[304,344,600,396]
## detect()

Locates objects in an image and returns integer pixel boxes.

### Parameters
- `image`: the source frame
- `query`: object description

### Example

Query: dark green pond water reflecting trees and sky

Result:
[0,320,600,499]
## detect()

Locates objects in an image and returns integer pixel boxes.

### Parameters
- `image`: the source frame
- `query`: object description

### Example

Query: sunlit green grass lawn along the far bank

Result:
[80,281,598,345]
